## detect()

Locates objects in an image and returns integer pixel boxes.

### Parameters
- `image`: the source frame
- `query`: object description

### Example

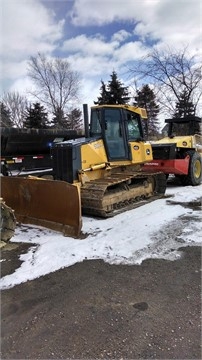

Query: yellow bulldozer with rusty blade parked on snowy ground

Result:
[1,104,166,237]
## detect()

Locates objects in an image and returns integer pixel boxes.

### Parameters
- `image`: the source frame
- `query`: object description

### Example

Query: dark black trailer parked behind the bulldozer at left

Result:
[1,127,81,176]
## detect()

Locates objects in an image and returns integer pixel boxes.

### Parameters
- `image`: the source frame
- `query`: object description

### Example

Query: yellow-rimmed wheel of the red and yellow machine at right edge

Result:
[181,151,201,186]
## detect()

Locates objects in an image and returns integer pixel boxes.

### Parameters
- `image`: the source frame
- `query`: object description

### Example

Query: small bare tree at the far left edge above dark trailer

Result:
[2,91,29,128]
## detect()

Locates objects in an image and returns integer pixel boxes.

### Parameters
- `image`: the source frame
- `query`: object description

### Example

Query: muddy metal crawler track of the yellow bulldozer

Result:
[81,172,166,218]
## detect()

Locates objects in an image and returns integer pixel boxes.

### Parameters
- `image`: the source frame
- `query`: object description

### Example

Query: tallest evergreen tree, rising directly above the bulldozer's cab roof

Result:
[94,71,130,105]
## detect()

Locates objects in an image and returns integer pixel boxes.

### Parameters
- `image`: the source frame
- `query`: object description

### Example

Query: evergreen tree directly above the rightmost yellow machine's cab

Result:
[173,91,195,118]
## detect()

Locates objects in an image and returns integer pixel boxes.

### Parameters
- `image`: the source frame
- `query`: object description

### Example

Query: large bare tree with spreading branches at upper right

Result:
[130,47,202,115]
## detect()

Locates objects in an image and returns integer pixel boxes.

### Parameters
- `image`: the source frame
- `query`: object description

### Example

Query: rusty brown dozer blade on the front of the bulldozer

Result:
[1,176,82,237]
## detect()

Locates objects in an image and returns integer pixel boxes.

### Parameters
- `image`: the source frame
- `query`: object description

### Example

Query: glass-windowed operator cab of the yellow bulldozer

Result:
[90,105,143,161]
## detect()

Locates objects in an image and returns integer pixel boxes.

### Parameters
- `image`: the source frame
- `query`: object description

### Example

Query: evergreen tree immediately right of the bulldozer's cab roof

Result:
[134,85,159,138]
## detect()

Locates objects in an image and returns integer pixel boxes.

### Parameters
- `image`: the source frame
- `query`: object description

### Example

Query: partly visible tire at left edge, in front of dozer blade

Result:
[0,198,16,242]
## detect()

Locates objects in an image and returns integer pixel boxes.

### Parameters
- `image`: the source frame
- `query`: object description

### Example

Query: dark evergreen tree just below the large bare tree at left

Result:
[23,102,48,129]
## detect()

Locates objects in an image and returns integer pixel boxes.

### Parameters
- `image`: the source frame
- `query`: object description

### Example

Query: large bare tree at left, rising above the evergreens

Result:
[28,53,80,113]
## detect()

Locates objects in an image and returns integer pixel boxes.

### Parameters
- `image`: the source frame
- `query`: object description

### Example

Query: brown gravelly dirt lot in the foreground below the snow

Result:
[1,240,201,359]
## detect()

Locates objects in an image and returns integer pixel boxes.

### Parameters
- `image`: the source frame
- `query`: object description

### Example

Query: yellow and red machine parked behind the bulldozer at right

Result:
[144,115,202,186]
